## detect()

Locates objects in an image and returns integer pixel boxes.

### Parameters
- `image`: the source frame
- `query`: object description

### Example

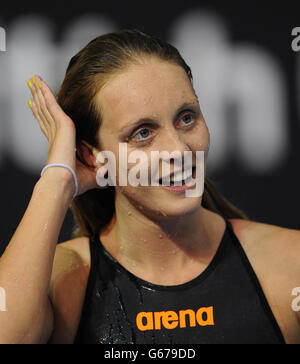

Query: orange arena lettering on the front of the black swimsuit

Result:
[136,306,215,331]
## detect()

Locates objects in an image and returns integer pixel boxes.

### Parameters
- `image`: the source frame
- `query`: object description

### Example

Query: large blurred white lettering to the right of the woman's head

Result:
[170,9,289,173]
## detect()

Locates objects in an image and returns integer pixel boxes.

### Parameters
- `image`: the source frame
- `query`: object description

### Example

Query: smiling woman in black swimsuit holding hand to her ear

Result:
[0,30,300,344]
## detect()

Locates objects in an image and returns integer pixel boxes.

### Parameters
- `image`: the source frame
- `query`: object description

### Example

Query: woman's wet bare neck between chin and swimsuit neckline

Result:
[101,193,224,277]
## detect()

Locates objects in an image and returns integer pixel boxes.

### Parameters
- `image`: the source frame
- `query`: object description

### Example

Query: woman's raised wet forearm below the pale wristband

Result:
[0,168,74,342]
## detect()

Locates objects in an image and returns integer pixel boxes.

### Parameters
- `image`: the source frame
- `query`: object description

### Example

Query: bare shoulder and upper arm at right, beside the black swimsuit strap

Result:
[230,219,300,344]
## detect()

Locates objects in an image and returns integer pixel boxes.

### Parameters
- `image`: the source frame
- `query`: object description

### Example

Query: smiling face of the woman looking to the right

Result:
[95,59,210,219]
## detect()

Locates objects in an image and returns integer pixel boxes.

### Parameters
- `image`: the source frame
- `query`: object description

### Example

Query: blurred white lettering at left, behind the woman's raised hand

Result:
[6,15,116,173]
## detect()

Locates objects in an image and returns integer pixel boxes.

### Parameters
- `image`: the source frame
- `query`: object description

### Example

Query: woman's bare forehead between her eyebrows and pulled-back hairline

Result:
[95,60,196,129]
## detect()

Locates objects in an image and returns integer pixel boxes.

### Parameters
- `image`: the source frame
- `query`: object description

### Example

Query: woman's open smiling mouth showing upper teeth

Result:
[159,166,196,192]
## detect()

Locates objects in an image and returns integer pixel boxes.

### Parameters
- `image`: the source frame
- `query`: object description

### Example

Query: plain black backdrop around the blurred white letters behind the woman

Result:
[0,0,300,253]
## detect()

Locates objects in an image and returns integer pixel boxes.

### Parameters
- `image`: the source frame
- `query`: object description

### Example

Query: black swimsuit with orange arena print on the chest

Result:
[75,220,285,344]
